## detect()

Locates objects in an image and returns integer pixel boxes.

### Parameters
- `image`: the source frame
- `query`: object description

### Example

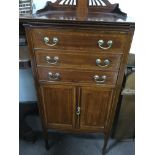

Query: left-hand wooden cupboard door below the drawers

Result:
[41,85,75,129]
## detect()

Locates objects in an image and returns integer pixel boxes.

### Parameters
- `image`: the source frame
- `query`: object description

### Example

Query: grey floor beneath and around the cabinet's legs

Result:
[19,116,135,155]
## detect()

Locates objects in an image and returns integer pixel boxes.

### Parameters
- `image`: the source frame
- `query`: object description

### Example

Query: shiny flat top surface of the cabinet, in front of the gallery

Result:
[19,11,134,24]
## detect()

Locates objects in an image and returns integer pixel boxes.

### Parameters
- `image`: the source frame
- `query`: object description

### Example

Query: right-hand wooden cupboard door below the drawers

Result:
[80,87,113,130]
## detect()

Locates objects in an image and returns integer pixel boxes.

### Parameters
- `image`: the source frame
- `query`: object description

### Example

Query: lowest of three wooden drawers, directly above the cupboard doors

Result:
[37,67,117,85]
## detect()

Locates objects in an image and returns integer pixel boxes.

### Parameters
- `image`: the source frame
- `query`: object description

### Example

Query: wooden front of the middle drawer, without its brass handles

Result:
[35,50,122,71]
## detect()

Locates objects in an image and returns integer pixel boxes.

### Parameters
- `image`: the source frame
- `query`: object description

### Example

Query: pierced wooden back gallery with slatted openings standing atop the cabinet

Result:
[37,0,127,19]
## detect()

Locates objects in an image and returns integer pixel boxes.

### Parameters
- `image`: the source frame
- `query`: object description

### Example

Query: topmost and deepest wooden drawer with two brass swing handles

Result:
[32,28,126,53]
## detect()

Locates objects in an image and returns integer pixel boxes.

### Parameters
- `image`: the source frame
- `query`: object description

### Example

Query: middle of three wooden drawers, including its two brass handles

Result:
[35,50,121,70]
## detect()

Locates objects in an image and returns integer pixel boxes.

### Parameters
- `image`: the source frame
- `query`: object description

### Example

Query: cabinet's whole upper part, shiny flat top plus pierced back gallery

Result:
[20,0,134,25]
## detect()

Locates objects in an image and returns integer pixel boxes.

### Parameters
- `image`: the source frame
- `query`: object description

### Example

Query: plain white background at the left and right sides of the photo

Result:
[0,0,155,155]
